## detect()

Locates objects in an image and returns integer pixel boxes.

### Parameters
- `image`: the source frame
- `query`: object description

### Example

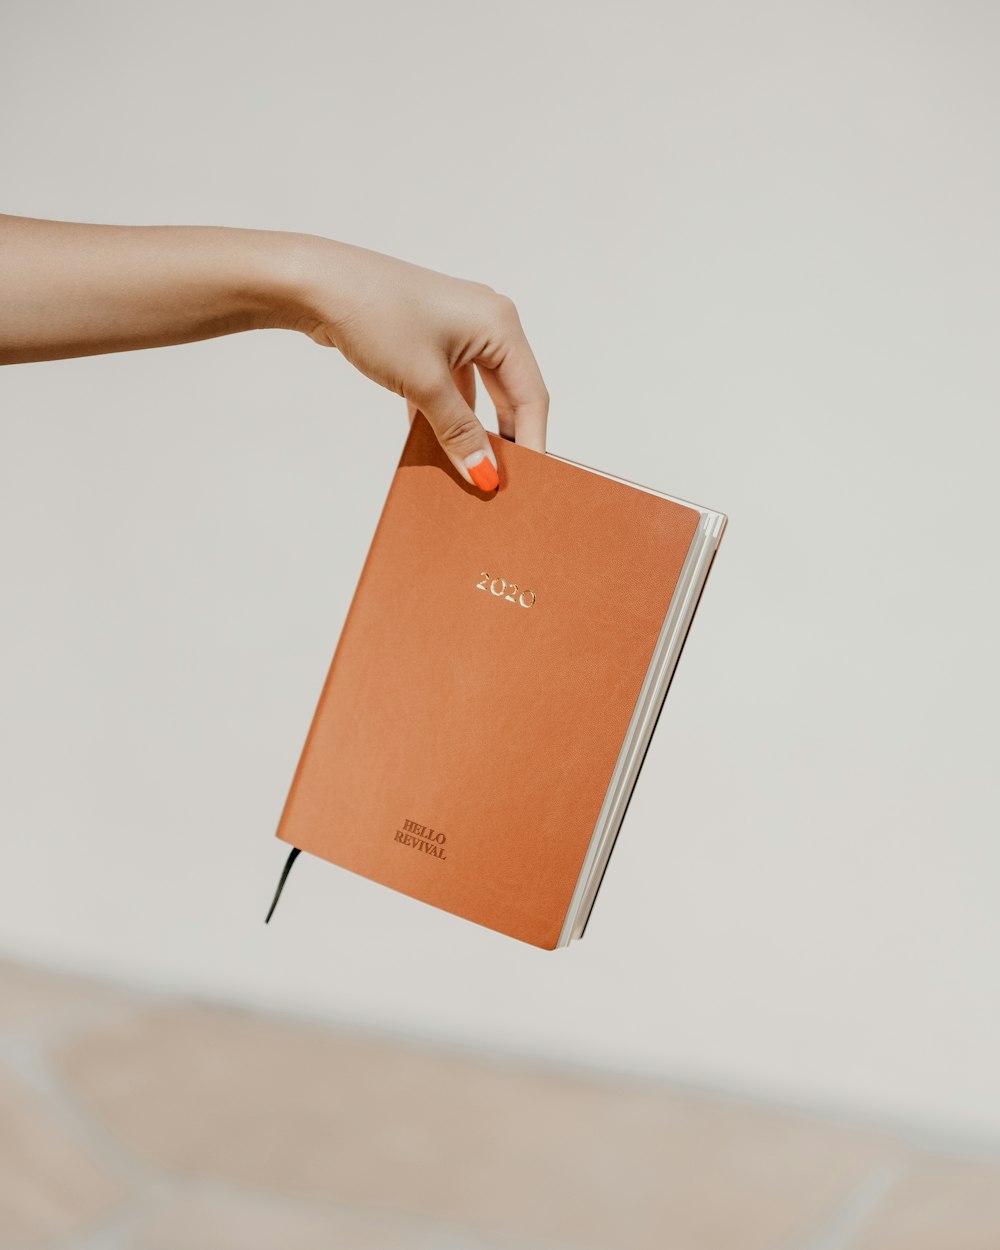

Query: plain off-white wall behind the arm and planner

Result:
[0,0,1000,1136]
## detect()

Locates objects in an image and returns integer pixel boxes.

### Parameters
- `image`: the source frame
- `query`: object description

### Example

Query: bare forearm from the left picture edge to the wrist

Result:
[0,215,304,364]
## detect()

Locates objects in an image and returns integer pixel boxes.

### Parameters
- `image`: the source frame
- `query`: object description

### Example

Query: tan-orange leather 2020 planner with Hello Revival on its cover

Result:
[269,413,728,950]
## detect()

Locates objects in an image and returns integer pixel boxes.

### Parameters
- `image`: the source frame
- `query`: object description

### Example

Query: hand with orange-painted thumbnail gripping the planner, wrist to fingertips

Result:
[270,236,549,490]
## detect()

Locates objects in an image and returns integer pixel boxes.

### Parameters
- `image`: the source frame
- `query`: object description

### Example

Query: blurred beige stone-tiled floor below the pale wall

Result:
[0,963,1000,1250]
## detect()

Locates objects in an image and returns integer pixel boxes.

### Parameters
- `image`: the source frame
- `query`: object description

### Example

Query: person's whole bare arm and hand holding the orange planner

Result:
[0,215,549,490]
